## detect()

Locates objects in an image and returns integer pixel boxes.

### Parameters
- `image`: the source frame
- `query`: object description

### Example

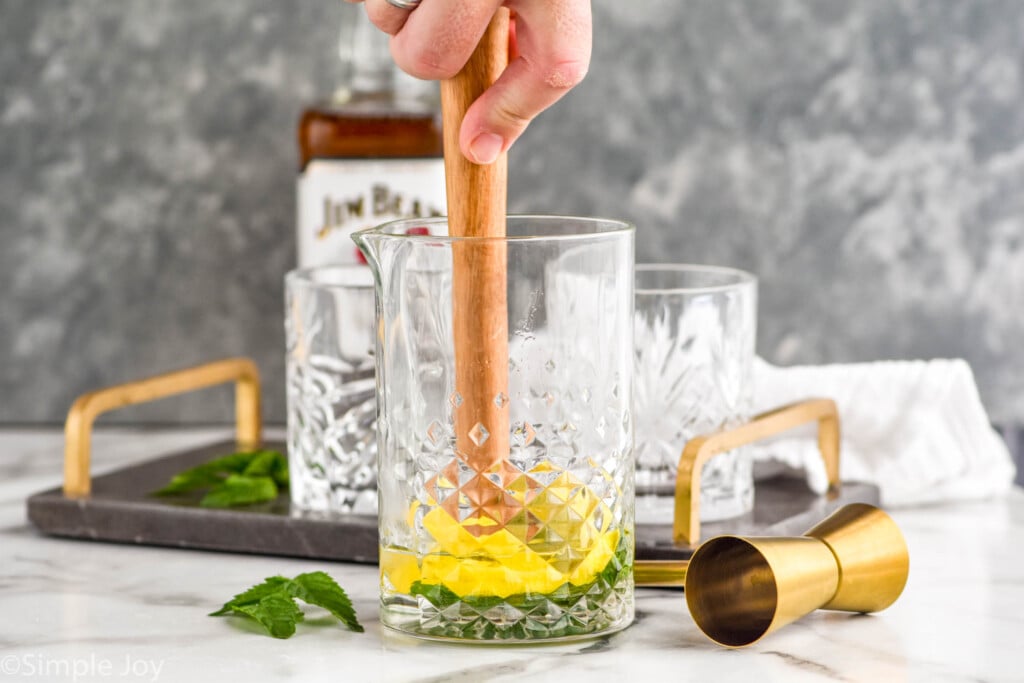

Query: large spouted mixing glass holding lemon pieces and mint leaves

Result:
[356,217,634,642]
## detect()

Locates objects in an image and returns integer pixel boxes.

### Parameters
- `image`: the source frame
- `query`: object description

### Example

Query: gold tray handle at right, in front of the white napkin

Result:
[672,398,840,547]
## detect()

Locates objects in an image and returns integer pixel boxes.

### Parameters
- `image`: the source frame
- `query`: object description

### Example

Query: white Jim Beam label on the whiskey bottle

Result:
[296,159,445,267]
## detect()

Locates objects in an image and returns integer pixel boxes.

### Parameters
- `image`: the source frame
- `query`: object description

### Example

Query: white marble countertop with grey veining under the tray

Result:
[0,429,1024,683]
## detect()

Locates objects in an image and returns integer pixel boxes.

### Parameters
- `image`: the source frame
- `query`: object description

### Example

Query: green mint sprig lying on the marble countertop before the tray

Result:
[210,571,362,638]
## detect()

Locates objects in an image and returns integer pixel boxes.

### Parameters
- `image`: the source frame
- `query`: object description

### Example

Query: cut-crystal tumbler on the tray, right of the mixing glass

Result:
[634,264,757,524]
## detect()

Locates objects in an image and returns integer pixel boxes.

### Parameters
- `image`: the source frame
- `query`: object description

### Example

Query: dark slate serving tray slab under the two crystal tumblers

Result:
[28,441,879,563]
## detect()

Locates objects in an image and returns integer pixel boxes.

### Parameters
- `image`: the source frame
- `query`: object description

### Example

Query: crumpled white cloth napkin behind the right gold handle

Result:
[753,359,1015,507]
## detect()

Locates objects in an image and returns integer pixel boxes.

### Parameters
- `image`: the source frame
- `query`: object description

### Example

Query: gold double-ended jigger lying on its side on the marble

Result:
[685,504,910,647]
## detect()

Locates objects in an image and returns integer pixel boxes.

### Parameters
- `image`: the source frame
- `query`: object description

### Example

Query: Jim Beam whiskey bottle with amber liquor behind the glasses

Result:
[296,8,445,267]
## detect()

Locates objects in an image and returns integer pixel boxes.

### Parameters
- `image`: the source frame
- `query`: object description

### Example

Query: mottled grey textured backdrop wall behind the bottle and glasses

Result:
[0,0,1024,423]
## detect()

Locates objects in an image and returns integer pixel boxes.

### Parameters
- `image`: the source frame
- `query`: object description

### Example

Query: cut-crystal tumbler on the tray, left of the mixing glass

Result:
[285,264,377,514]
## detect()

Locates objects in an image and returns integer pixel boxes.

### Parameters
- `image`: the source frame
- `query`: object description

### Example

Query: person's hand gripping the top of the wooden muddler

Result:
[348,0,591,164]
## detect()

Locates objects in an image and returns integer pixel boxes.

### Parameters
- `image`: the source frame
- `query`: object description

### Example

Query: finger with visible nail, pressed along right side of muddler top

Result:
[458,0,591,164]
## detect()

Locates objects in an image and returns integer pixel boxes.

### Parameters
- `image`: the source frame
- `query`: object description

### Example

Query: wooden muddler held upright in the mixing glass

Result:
[441,8,509,472]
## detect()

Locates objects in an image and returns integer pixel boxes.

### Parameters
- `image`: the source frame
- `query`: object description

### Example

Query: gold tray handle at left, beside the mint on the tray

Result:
[63,357,262,498]
